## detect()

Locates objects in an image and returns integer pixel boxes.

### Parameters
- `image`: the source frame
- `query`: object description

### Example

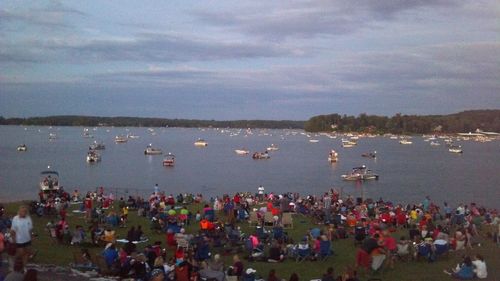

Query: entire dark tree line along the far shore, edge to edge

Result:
[0,110,500,134]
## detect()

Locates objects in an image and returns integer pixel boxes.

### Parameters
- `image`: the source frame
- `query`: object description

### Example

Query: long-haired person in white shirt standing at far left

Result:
[10,206,33,266]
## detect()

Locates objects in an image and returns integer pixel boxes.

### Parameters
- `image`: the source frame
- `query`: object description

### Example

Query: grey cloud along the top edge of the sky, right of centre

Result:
[194,0,460,40]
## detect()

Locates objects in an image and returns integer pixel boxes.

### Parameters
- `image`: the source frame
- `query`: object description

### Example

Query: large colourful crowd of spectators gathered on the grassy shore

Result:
[0,186,500,281]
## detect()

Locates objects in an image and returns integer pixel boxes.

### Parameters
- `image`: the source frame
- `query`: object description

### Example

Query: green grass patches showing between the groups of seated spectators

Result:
[1,200,500,281]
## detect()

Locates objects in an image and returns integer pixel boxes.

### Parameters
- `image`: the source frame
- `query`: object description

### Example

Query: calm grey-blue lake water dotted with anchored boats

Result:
[0,126,500,207]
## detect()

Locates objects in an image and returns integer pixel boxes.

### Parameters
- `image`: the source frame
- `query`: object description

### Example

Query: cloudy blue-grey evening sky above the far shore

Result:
[0,0,500,120]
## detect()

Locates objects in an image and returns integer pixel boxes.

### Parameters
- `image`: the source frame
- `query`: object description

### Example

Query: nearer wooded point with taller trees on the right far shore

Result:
[304,110,500,134]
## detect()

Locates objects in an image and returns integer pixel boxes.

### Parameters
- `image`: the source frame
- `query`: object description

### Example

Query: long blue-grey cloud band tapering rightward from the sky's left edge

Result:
[0,33,296,63]
